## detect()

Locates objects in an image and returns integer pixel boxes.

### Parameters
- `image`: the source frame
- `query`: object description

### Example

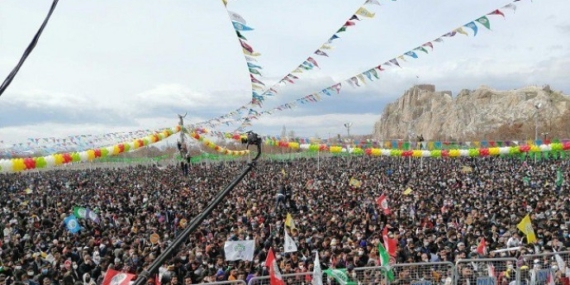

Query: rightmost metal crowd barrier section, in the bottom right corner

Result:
[518,251,570,285]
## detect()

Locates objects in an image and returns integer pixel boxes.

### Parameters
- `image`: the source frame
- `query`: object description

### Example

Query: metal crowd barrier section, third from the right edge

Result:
[386,262,455,285]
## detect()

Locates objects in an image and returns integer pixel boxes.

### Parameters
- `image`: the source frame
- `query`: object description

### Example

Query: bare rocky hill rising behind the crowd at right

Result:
[374,85,570,140]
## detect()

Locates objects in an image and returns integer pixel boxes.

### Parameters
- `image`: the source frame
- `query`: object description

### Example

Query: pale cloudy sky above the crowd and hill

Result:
[0,0,570,144]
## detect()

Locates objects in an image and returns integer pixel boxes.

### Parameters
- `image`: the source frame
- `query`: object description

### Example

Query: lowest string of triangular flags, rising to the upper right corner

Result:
[226,0,521,132]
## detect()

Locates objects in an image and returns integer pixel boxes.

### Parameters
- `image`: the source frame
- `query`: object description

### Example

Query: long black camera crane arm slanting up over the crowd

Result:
[134,146,261,285]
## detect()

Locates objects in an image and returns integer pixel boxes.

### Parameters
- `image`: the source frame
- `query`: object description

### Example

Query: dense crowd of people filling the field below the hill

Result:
[0,157,570,285]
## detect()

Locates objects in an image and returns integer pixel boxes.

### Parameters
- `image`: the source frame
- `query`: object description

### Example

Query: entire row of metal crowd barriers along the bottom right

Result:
[237,255,570,285]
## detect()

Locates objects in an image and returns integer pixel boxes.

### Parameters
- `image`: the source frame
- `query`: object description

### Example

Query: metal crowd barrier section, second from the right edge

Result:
[455,258,521,285]
